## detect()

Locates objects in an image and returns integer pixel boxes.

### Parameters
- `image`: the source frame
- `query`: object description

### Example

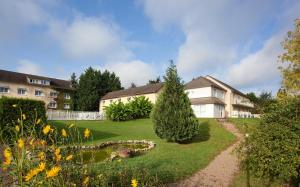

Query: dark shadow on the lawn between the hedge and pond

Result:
[52,121,120,141]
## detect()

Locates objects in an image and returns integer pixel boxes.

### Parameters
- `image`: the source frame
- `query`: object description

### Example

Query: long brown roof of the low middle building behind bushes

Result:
[101,83,163,100]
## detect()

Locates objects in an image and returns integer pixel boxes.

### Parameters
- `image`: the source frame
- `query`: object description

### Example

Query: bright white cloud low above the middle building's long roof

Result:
[100,60,157,88]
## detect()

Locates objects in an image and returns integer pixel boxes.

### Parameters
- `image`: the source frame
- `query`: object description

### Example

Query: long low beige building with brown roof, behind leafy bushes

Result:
[99,83,163,112]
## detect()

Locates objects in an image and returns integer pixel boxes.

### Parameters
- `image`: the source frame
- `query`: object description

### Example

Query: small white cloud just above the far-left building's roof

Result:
[16,59,43,75]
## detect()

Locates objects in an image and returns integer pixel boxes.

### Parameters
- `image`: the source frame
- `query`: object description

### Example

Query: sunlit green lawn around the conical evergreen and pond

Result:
[52,119,235,183]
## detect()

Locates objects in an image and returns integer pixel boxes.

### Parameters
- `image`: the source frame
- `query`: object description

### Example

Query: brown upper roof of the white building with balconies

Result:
[184,76,226,91]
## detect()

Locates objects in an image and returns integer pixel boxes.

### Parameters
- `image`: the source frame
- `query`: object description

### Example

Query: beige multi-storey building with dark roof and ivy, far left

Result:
[0,70,73,110]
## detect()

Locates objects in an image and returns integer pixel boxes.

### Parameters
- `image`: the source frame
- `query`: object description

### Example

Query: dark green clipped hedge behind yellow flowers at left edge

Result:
[0,97,47,139]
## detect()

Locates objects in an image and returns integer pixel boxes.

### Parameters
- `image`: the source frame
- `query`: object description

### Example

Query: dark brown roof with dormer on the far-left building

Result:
[0,70,73,90]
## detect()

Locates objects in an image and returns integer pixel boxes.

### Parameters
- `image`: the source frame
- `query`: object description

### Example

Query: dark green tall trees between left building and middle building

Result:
[74,67,122,111]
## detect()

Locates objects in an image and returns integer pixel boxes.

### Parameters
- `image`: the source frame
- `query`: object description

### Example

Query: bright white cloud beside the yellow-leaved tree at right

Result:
[227,34,284,88]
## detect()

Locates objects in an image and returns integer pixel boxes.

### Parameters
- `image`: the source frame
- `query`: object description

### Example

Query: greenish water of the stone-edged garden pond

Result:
[75,143,149,164]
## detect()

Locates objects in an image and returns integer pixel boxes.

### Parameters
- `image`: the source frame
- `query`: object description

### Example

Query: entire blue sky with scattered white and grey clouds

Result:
[0,0,300,92]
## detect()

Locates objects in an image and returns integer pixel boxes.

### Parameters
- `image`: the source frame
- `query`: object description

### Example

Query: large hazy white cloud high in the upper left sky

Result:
[50,16,132,61]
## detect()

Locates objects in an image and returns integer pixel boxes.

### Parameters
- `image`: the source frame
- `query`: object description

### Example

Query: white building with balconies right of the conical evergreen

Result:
[185,76,254,118]
